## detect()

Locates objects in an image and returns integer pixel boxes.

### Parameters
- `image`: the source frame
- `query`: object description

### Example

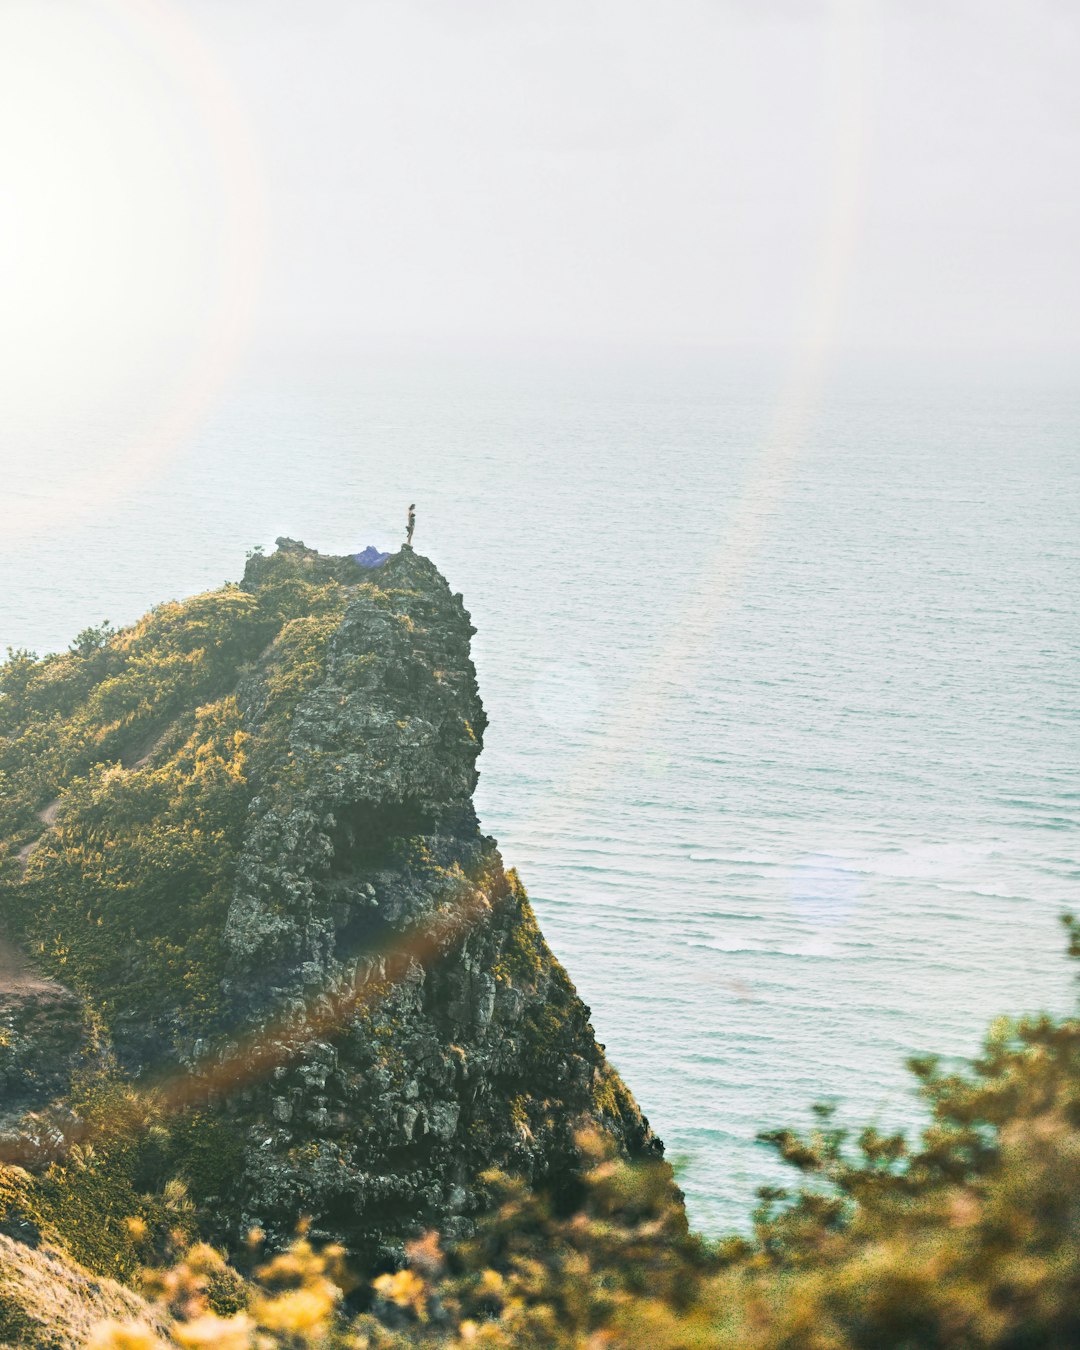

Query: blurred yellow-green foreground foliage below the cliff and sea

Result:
[88,921,1080,1350]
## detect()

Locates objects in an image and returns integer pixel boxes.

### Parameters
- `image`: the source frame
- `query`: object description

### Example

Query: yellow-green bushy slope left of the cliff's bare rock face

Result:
[0,552,348,1035]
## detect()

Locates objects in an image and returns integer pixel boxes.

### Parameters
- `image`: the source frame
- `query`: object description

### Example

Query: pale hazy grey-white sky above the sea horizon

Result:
[0,0,1080,410]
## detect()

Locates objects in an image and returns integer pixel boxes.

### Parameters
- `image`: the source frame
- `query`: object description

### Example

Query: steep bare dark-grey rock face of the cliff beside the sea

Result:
[205,551,657,1245]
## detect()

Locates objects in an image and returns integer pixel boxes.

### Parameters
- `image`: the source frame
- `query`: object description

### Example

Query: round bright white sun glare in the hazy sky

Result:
[0,0,259,537]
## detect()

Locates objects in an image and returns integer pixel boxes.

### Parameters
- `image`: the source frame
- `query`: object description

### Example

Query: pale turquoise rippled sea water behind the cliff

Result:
[0,358,1080,1230]
